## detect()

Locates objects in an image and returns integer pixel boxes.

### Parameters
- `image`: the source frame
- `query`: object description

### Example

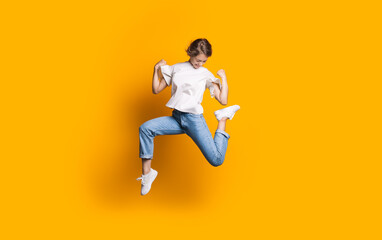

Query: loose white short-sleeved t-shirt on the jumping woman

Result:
[161,61,221,114]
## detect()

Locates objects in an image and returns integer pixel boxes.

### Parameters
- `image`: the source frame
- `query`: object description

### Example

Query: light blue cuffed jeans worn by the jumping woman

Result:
[139,109,230,167]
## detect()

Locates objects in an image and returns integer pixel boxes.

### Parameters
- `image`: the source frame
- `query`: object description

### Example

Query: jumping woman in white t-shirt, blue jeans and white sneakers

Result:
[137,38,240,195]
